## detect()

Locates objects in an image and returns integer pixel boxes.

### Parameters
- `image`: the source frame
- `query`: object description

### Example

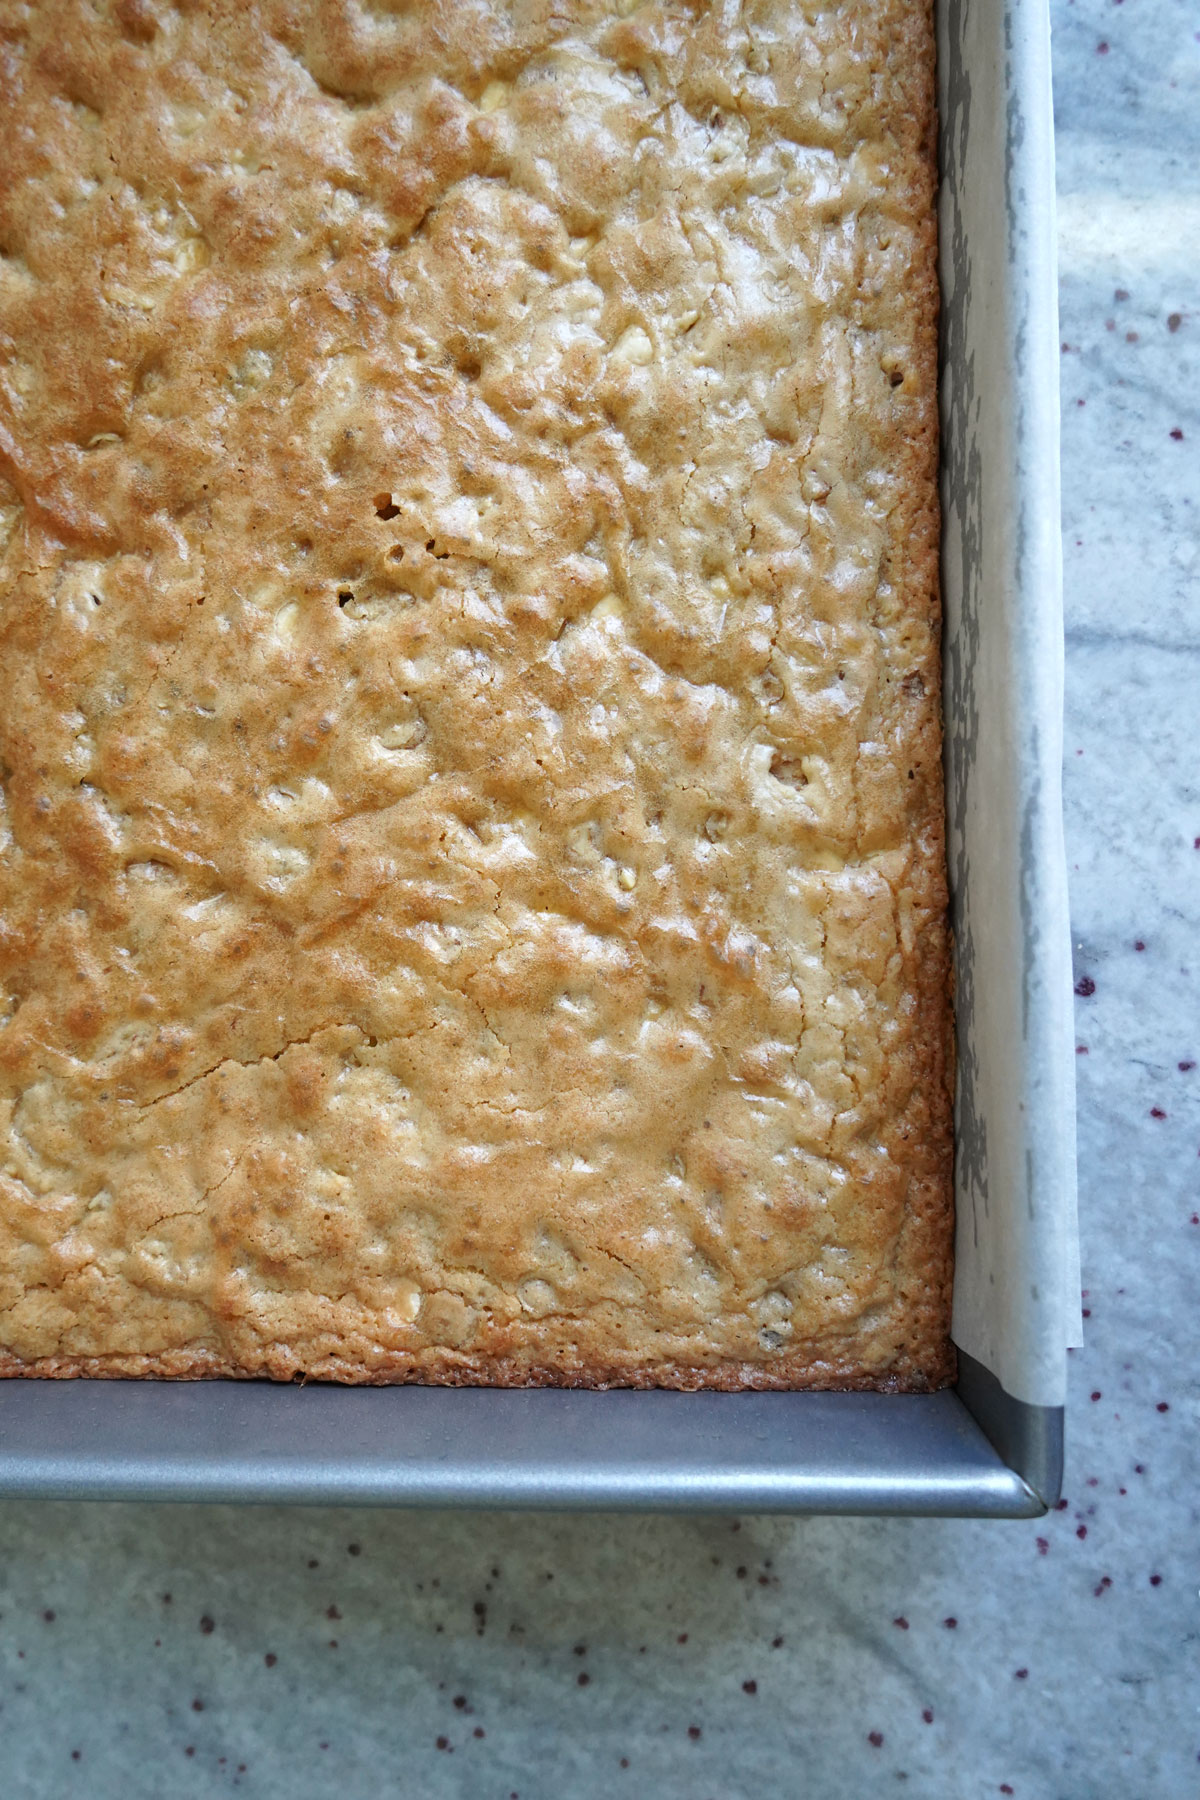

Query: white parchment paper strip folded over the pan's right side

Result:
[939,0,1081,1406]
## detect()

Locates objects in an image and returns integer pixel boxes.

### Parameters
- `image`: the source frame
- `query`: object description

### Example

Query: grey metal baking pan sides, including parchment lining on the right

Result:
[0,0,1078,1517]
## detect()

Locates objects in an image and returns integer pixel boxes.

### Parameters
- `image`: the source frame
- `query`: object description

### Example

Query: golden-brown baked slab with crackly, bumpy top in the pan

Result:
[0,0,952,1388]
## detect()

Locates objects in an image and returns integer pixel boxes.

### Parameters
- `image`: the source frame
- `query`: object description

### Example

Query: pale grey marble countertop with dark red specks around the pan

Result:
[0,0,1200,1800]
